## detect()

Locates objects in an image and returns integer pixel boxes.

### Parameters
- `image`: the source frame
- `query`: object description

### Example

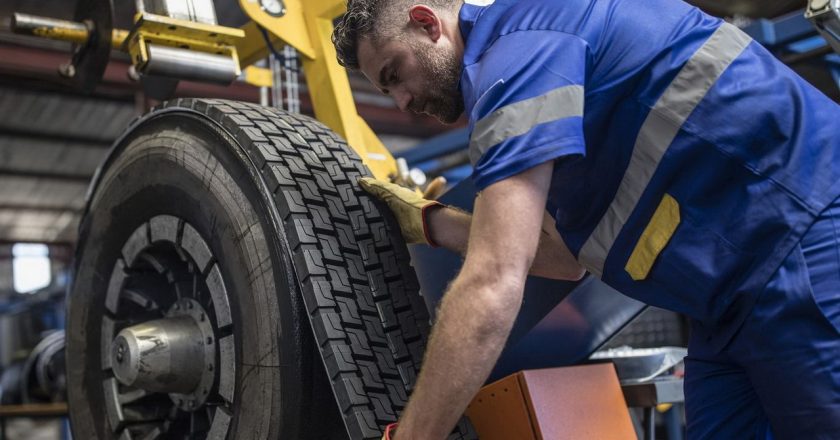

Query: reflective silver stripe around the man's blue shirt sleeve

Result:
[470,86,583,165]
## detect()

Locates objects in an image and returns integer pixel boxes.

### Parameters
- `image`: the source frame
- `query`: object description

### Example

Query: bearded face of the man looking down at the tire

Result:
[359,36,464,124]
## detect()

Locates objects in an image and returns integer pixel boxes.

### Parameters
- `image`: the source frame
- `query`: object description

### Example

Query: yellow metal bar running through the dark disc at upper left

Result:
[11,13,128,49]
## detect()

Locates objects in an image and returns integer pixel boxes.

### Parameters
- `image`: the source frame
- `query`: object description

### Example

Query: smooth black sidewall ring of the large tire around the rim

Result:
[67,115,314,439]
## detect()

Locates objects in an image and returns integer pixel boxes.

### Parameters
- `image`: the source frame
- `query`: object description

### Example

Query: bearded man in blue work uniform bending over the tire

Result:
[333,0,840,439]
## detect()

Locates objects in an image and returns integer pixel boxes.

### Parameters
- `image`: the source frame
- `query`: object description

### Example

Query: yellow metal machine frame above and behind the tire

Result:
[15,0,400,180]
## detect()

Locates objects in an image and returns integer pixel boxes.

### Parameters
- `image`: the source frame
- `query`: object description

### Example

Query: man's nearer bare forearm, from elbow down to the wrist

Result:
[396,275,522,440]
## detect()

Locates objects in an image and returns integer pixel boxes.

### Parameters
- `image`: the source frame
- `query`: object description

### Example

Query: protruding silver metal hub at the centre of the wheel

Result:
[111,298,216,410]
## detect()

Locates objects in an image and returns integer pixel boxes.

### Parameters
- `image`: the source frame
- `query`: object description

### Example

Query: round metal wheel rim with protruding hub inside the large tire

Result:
[100,215,236,439]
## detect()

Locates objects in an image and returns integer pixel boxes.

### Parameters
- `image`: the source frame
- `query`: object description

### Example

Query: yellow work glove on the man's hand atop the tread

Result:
[359,177,443,247]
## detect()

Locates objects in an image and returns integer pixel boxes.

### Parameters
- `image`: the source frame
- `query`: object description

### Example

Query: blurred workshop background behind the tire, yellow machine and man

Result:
[0,0,840,439]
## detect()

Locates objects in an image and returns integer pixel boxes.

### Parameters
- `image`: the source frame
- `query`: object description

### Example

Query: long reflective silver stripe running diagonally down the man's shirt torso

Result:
[578,23,752,277]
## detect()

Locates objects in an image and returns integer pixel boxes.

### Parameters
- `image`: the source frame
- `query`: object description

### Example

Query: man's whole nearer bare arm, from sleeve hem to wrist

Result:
[396,164,552,440]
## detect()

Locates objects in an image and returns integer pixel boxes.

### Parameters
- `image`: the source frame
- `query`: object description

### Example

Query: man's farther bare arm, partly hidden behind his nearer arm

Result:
[428,202,586,281]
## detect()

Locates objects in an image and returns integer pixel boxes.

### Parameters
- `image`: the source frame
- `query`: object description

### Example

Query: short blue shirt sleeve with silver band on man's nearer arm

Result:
[465,31,589,190]
